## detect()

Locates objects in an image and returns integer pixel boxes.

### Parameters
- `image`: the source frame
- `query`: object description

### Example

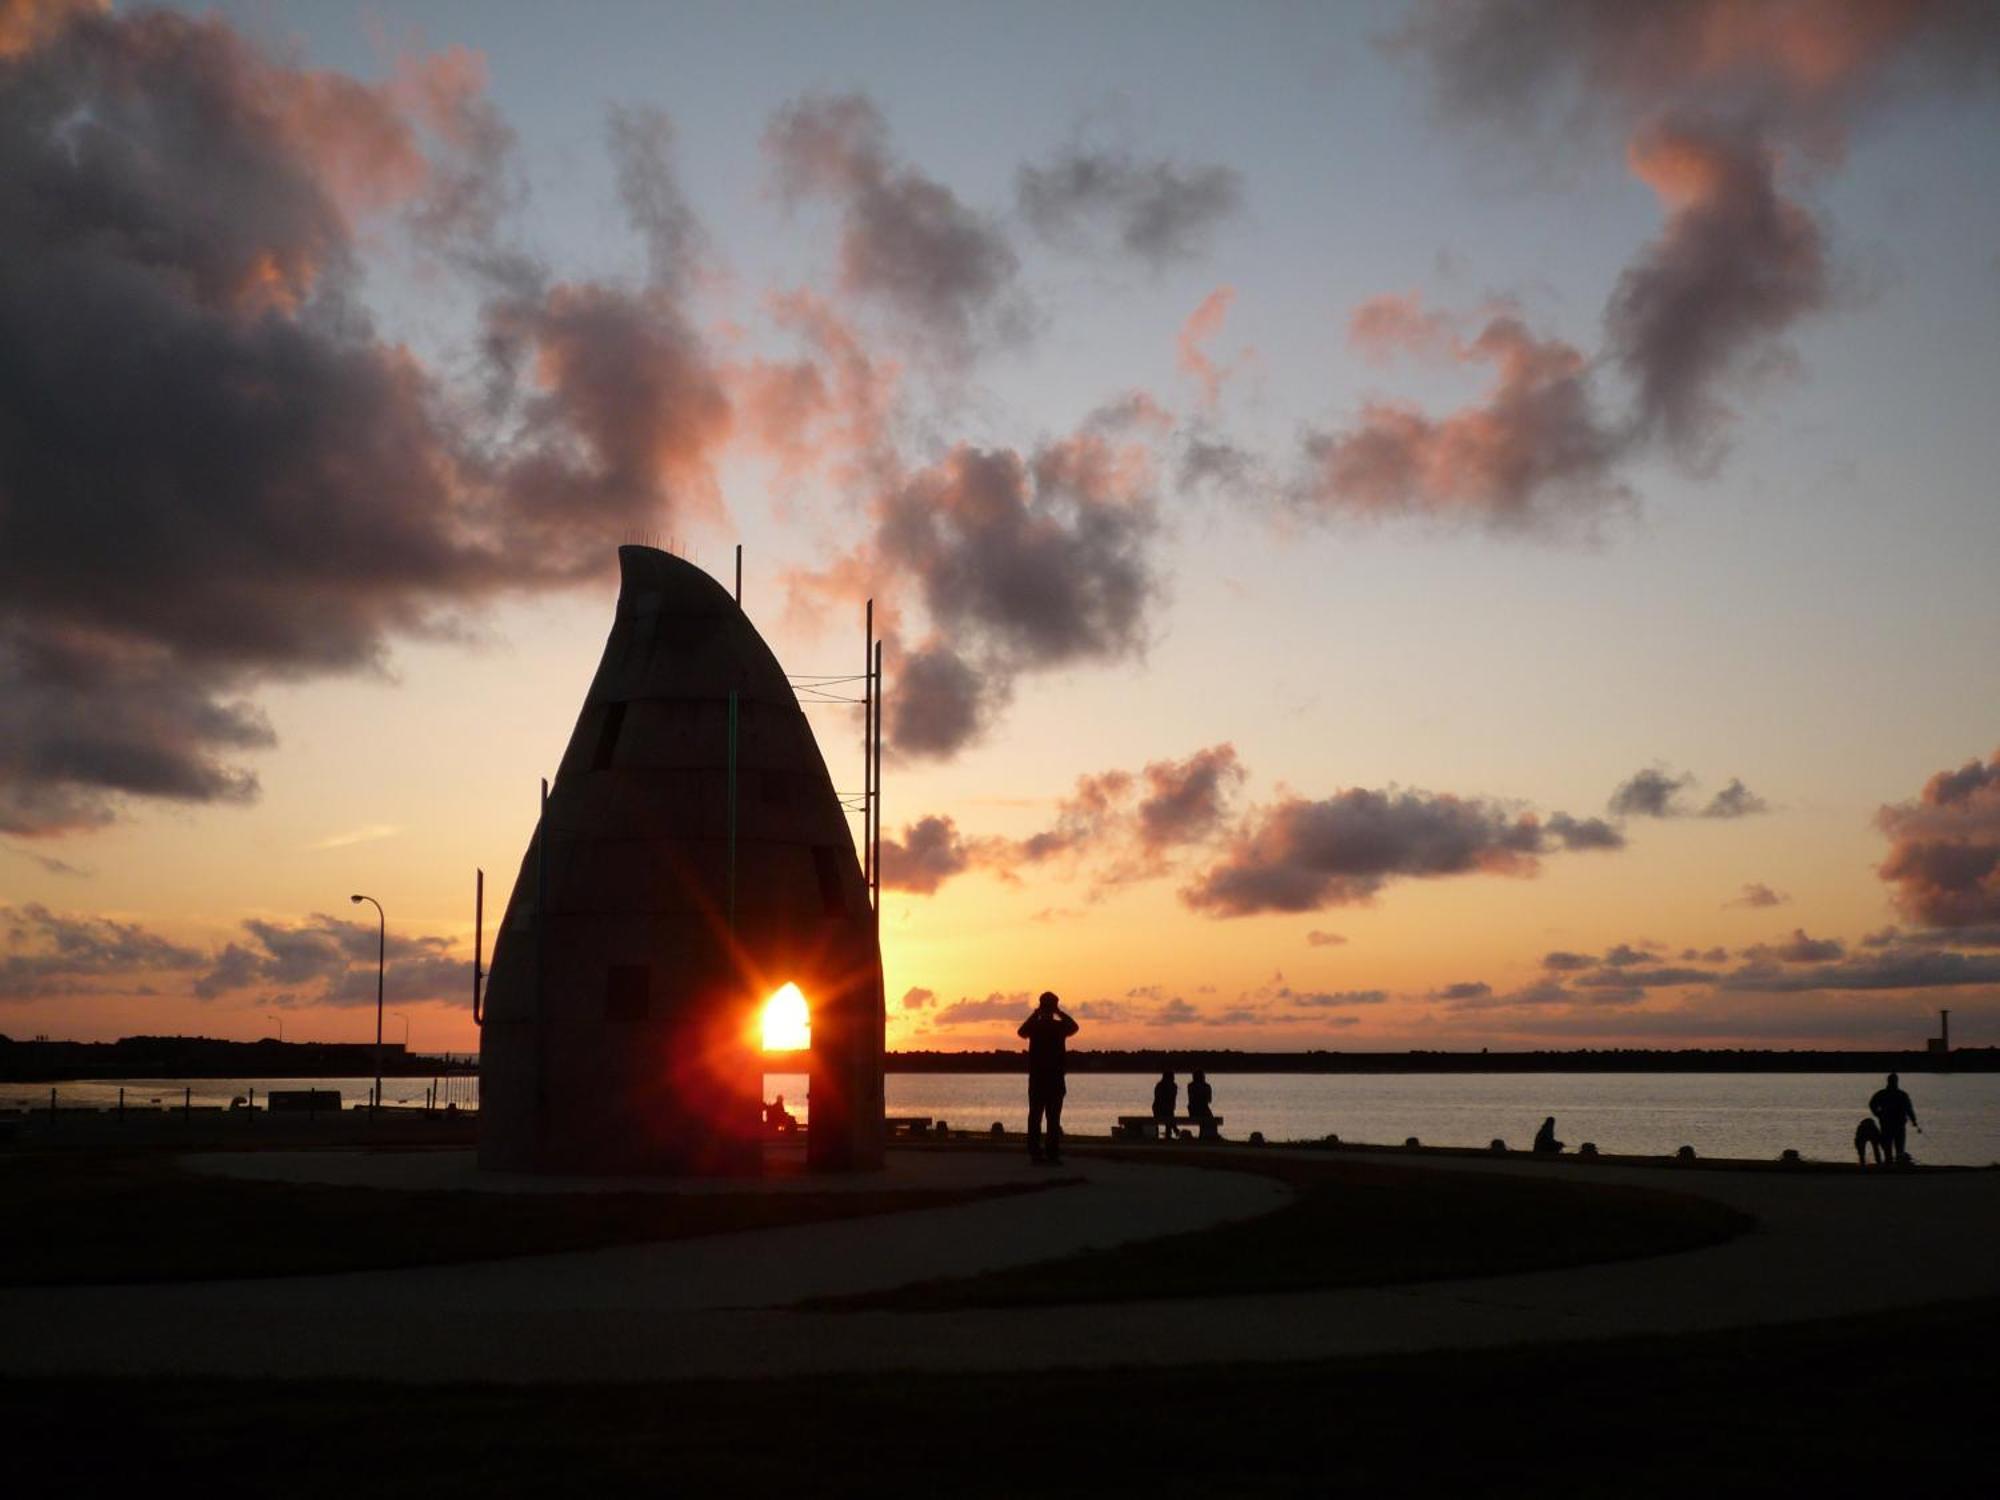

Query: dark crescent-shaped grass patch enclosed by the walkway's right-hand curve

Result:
[814,1150,1754,1312]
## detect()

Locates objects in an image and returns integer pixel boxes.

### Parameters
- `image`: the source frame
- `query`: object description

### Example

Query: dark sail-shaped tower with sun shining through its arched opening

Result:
[480,546,882,1172]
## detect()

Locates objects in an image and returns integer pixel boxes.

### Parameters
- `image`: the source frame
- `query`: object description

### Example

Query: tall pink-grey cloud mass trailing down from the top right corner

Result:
[1376,0,2000,524]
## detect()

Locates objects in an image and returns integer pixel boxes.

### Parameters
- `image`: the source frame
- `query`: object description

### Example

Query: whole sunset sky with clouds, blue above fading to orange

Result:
[0,0,2000,1050]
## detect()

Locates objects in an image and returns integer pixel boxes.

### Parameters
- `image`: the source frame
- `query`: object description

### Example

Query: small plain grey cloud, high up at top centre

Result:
[1014,146,1244,270]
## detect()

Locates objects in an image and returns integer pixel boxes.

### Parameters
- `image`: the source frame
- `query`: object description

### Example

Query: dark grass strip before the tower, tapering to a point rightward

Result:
[0,1152,1054,1286]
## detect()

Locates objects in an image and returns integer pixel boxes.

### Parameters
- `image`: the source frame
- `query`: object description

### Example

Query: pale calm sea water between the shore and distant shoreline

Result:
[19,1072,2000,1166]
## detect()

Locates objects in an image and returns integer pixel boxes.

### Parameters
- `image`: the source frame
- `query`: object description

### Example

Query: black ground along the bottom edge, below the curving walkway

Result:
[0,1302,2000,1500]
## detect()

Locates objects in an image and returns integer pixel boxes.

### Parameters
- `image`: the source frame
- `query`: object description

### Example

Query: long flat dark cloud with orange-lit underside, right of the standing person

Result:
[1180,788,1608,916]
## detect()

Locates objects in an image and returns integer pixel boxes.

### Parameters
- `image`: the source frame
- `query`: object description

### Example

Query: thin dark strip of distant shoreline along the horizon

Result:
[0,1036,2000,1084]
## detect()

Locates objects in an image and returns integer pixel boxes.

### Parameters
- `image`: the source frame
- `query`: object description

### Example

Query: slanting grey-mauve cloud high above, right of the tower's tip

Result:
[764,94,1020,360]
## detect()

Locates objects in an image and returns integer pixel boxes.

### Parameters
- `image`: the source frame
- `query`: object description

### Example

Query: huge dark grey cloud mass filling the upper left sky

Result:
[0,10,728,834]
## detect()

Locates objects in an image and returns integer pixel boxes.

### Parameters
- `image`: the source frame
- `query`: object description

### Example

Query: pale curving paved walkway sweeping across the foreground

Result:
[0,1154,2000,1382]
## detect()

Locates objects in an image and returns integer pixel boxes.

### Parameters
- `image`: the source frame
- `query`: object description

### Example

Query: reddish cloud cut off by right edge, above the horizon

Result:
[1876,750,2000,928]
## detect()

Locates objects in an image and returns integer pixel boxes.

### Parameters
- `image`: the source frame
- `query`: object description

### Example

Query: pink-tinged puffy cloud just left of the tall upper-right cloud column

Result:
[1292,304,1632,532]
